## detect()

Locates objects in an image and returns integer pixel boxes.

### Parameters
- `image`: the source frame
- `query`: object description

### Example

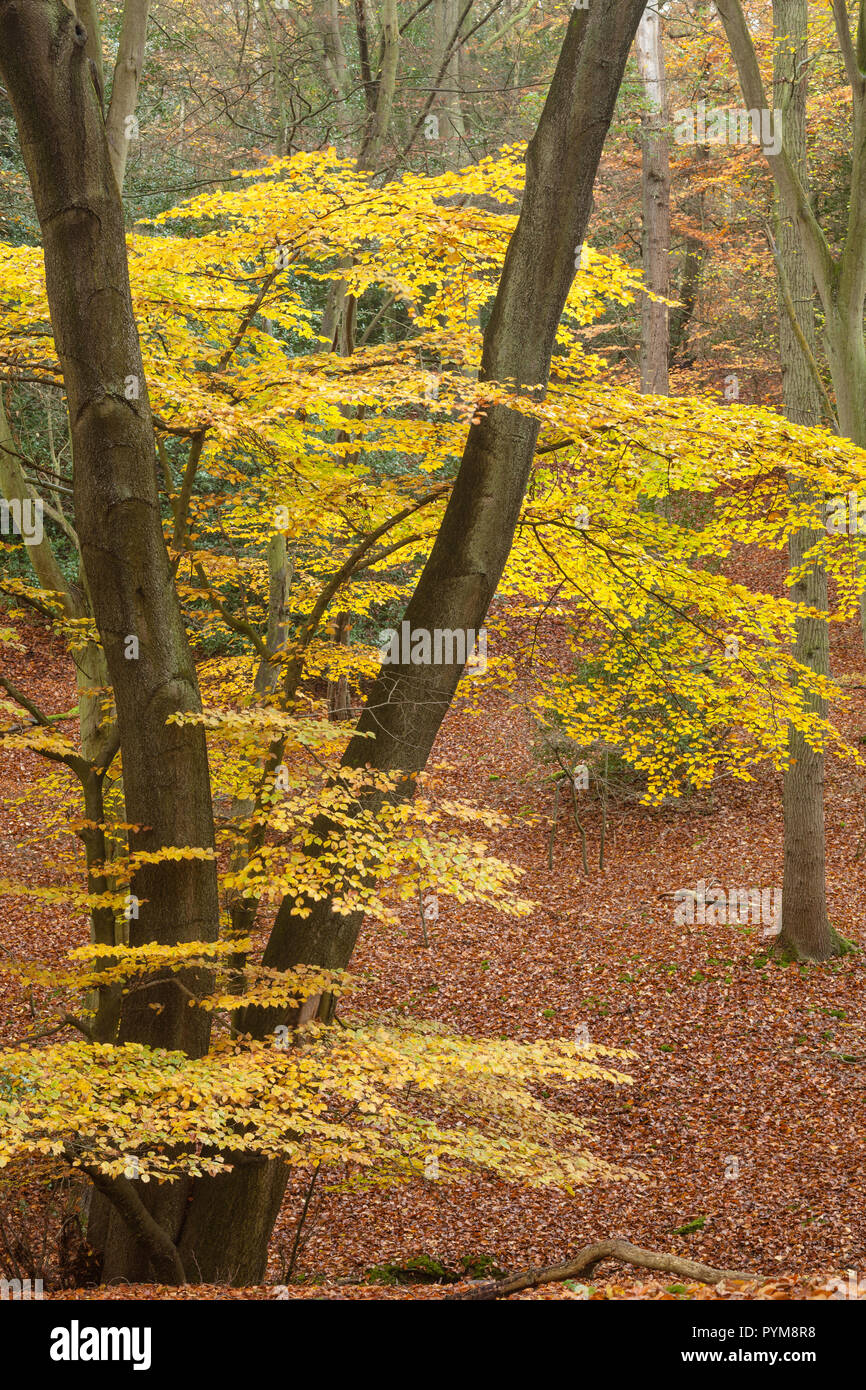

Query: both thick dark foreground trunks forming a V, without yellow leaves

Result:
[0,0,642,1282]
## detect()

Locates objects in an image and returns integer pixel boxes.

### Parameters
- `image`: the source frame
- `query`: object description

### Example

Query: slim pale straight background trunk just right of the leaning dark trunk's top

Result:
[635,10,670,396]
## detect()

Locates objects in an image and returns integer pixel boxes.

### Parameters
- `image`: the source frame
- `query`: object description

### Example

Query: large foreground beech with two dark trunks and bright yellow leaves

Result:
[6,0,866,1283]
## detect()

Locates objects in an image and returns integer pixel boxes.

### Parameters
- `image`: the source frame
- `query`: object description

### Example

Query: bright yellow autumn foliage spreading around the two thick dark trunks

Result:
[6,46,862,1279]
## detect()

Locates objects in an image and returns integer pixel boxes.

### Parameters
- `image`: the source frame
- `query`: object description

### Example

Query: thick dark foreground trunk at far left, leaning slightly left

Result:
[0,0,217,1039]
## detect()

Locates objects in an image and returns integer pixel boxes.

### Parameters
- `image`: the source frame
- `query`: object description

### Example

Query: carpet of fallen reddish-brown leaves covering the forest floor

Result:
[0,539,866,1298]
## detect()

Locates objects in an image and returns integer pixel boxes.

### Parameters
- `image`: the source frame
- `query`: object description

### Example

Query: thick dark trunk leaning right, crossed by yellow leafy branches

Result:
[174,0,645,1283]
